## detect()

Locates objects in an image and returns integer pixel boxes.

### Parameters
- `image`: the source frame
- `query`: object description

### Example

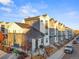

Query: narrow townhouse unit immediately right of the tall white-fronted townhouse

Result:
[48,18,57,45]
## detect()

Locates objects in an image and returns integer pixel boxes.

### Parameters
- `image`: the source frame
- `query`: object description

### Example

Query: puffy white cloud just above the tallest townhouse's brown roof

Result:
[19,4,39,16]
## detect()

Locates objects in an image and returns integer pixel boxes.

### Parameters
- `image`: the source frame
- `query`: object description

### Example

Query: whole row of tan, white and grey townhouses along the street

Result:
[0,14,74,56]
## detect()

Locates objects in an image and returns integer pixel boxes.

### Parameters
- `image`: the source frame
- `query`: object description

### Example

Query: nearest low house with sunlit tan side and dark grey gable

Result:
[8,23,44,51]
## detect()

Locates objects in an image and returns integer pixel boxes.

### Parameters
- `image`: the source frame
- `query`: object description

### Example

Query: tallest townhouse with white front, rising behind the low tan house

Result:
[25,14,50,46]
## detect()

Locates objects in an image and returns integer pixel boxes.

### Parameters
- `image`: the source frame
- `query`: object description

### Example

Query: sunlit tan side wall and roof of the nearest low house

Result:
[8,23,30,47]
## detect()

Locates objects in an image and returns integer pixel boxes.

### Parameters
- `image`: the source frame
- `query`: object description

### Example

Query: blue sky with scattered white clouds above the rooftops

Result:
[0,0,79,29]
